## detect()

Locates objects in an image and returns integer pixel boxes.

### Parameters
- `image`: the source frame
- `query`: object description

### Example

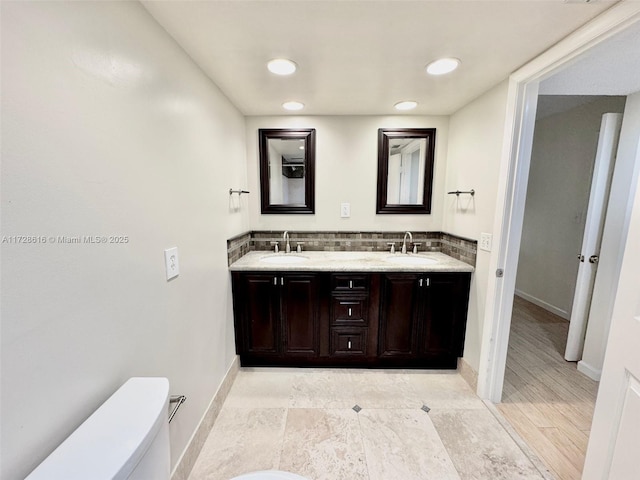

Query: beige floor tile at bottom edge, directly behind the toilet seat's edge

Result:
[280,408,369,480]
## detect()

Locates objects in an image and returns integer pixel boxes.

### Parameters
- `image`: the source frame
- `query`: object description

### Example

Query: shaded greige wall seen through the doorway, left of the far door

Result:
[516,97,625,319]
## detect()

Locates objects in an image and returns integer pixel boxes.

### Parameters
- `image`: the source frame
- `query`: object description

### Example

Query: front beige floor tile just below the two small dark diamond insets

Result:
[358,409,460,480]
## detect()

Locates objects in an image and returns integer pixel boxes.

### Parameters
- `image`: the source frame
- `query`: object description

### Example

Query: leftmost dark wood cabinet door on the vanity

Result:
[237,273,280,353]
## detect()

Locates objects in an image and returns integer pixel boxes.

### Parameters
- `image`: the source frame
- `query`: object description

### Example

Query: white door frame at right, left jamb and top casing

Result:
[477,2,640,403]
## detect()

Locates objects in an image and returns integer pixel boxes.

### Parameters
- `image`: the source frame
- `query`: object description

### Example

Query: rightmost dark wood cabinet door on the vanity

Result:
[420,274,469,357]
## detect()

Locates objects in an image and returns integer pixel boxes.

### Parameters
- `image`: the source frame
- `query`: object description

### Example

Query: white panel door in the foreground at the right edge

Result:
[582,138,640,480]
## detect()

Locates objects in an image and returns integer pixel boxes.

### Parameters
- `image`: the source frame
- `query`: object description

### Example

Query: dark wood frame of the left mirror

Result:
[258,128,316,214]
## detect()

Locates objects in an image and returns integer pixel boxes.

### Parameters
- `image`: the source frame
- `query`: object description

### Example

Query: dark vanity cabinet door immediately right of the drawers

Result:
[378,273,420,357]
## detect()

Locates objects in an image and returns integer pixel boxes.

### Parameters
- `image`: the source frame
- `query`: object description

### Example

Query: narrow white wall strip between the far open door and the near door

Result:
[578,92,640,378]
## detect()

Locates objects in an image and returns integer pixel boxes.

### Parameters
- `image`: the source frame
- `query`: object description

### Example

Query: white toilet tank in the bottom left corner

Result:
[26,377,171,480]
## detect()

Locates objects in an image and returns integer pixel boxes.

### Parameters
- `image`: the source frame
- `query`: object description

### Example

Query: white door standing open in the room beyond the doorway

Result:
[564,113,622,362]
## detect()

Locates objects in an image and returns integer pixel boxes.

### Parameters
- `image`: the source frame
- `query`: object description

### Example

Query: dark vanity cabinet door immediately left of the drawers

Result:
[281,274,320,355]
